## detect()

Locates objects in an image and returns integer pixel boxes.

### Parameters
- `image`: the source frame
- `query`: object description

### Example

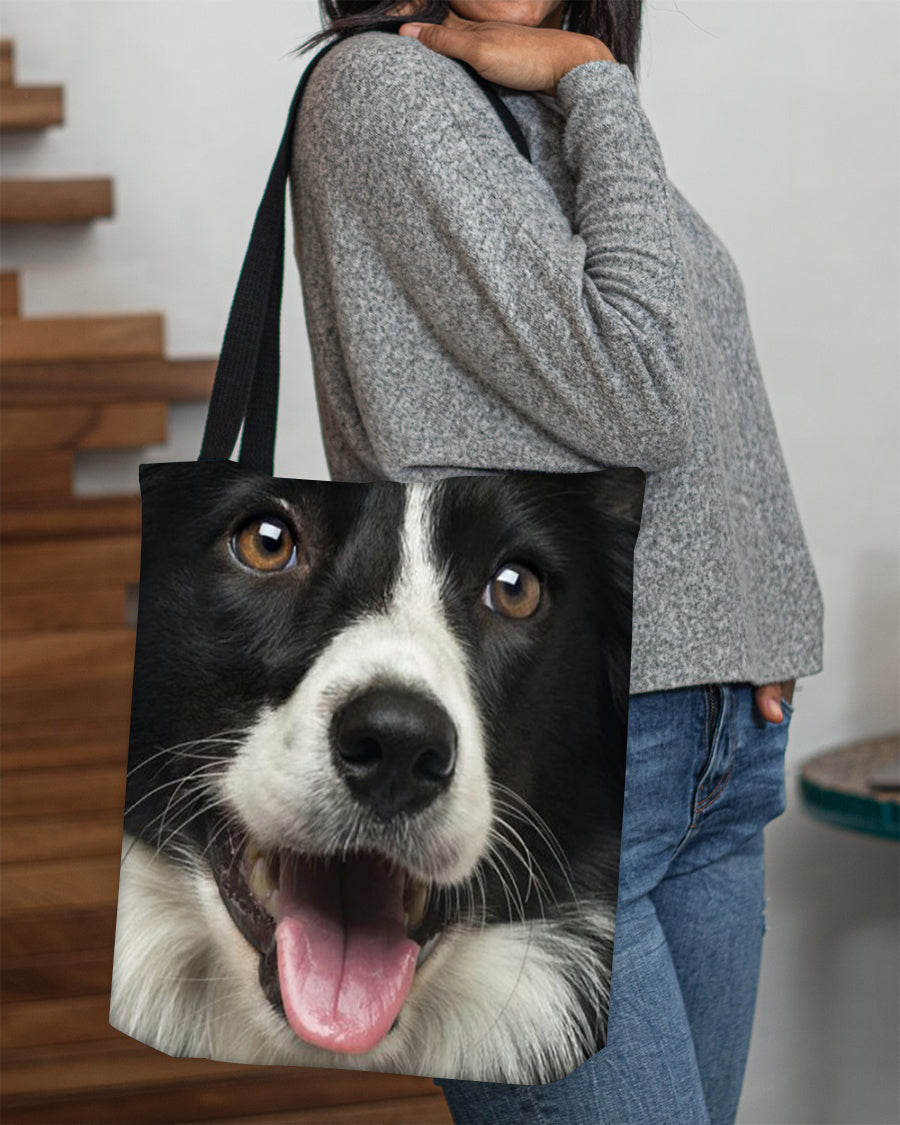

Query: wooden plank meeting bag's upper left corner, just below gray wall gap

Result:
[0,496,141,542]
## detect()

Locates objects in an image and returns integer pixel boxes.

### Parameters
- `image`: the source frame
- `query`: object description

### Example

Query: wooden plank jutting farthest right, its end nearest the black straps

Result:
[0,359,216,407]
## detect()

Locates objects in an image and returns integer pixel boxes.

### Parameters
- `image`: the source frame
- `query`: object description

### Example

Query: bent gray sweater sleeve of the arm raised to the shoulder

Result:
[295,33,696,470]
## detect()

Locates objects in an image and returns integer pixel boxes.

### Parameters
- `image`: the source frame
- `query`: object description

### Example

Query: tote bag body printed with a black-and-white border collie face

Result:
[110,461,644,1083]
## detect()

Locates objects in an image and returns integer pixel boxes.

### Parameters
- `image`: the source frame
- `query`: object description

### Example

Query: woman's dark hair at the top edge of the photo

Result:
[298,0,642,79]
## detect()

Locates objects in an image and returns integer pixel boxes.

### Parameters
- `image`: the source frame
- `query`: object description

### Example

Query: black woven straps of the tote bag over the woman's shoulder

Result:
[199,24,531,474]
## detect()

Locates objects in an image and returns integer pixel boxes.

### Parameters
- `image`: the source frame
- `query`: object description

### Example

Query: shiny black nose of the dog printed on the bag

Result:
[332,687,457,820]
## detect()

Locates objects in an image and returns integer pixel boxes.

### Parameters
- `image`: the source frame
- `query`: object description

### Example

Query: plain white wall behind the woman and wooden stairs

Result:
[2,0,900,1125]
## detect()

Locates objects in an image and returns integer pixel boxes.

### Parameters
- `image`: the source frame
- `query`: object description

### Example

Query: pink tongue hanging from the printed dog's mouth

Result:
[276,855,419,1054]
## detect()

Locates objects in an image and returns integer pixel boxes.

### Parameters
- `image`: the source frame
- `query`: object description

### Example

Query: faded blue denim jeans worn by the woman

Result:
[434,684,792,1125]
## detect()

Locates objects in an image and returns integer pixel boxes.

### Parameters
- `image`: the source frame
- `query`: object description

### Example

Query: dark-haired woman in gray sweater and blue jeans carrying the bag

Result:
[293,0,822,1125]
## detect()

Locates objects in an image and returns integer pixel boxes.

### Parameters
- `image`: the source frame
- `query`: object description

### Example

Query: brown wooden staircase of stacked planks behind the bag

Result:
[0,41,450,1125]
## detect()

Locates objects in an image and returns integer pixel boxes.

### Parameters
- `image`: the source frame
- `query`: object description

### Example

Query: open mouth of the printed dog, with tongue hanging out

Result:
[209,833,447,1054]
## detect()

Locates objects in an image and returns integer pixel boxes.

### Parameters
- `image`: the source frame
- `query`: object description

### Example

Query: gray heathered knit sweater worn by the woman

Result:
[291,32,822,692]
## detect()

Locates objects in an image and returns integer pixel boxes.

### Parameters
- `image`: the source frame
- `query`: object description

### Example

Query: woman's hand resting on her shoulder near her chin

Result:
[399,9,615,96]
